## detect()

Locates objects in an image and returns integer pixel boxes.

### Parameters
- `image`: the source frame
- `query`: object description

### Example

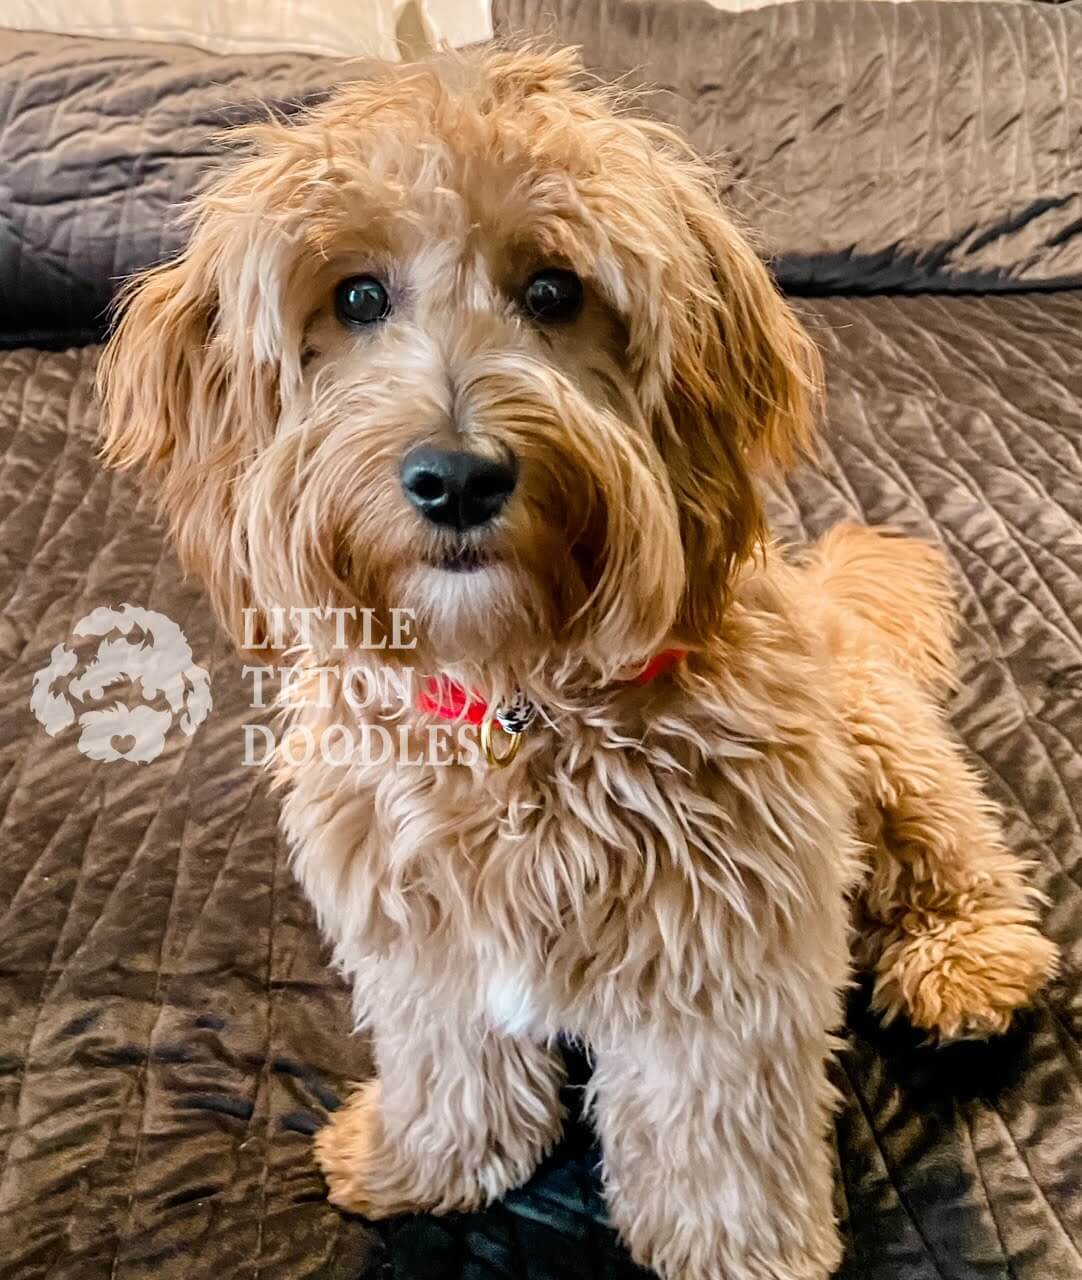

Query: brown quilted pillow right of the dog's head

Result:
[496,0,1082,293]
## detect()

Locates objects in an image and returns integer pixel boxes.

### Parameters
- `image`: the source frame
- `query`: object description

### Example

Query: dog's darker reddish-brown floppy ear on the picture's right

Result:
[637,135,821,643]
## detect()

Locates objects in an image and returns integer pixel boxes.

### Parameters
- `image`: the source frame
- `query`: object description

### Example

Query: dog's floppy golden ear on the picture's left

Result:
[99,229,274,644]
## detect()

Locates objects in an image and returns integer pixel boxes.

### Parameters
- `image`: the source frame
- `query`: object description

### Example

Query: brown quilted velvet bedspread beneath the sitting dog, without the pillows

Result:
[0,292,1082,1280]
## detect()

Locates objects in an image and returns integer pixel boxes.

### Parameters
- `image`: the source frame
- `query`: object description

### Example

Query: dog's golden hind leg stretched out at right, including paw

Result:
[840,659,1056,1039]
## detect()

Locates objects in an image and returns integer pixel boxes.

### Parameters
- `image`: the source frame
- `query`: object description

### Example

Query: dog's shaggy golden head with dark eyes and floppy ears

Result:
[102,51,818,671]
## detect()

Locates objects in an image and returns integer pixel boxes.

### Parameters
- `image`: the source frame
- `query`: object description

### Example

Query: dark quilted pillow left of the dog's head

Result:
[0,31,343,346]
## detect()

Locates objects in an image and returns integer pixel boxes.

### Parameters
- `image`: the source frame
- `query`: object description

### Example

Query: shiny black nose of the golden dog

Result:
[398,444,517,530]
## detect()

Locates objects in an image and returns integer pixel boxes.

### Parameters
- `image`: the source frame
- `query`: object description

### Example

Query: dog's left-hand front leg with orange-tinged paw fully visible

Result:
[315,1002,563,1217]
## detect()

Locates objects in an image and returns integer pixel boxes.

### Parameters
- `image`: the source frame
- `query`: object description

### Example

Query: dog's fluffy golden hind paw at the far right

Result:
[873,911,1056,1041]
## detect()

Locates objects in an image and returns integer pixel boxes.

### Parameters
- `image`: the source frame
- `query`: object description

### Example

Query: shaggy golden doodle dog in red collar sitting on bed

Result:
[102,51,1055,1280]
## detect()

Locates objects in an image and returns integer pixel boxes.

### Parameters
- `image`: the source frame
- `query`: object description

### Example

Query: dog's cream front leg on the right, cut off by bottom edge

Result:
[590,1013,840,1280]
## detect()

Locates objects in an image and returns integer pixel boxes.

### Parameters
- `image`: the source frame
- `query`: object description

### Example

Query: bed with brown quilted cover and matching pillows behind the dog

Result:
[0,0,1082,1280]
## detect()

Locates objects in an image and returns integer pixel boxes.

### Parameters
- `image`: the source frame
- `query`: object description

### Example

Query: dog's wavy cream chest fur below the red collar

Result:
[286,622,857,1038]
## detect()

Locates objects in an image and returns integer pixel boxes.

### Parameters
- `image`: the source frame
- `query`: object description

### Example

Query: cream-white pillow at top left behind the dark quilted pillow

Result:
[0,0,492,61]
